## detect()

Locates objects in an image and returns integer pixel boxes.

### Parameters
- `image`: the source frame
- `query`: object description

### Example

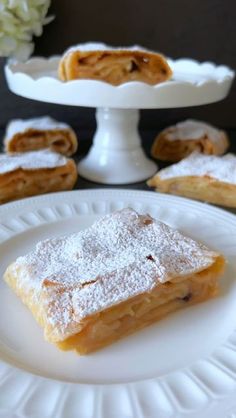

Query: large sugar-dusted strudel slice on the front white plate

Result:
[4,208,225,354]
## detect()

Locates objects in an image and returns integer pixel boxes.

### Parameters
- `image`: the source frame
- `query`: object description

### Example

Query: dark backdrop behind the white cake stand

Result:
[0,0,236,145]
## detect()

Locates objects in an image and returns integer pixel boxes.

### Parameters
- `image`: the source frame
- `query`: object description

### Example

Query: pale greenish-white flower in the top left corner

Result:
[0,0,53,60]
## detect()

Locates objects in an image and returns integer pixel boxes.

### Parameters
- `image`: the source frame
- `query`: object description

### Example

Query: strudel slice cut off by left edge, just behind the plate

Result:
[0,150,78,203]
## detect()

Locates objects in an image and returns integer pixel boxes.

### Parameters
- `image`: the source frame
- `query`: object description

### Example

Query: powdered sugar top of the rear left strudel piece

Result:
[4,116,70,143]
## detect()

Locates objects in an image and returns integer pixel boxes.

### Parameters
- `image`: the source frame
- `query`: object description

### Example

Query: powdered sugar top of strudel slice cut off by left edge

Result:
[0,149,68,175]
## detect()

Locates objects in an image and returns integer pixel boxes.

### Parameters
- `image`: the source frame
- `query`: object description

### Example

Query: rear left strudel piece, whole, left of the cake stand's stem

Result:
[4,116,78,157]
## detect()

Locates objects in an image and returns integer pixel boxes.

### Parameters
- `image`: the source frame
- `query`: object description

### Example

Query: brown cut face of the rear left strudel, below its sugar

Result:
[5,128,78,157]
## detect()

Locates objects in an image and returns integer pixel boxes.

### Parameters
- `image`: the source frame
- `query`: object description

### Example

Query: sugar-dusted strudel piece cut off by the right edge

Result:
[148,152,236,208]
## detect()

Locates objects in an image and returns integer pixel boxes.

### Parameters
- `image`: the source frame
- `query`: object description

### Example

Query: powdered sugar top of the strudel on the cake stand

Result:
[63,42,153,56]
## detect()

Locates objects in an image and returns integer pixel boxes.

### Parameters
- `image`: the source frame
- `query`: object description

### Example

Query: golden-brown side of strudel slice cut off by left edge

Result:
[0,160,78,203]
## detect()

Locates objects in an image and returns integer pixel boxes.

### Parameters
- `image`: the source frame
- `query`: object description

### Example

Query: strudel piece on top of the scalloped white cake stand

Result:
[58,43,172,86]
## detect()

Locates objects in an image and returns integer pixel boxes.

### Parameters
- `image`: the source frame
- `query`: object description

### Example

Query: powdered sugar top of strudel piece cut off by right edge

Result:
[156,152,236,184]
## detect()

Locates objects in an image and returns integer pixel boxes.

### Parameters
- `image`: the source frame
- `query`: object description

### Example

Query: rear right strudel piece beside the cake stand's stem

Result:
[151,119,229,162]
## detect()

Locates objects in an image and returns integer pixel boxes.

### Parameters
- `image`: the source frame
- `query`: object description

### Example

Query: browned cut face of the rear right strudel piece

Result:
[151,127,229,162]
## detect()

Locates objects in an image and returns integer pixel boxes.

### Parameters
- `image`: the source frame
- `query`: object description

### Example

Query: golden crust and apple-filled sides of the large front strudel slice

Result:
[4,256,225,354]
